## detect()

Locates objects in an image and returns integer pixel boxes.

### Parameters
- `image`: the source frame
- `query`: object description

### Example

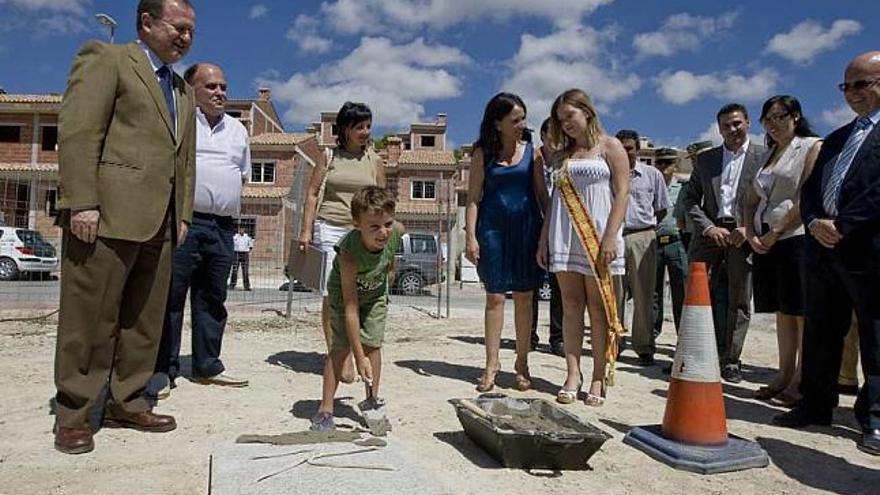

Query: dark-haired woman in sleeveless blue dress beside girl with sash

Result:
[465,93,547,392]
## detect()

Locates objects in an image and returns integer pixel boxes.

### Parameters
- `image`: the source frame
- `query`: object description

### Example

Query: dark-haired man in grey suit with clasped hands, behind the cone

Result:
[682,103,764,383]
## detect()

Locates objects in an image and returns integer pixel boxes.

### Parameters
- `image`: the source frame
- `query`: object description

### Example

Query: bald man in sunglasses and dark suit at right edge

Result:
[773,51,880,455]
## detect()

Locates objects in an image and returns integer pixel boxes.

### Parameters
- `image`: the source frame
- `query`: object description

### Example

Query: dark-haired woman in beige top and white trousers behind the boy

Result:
[299,101,385,383]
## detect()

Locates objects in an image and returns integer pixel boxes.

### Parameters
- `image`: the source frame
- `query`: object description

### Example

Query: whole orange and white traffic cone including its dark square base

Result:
[623,262,770,474]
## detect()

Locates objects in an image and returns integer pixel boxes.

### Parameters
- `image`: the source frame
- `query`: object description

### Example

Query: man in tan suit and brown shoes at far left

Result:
[55,0,195,454]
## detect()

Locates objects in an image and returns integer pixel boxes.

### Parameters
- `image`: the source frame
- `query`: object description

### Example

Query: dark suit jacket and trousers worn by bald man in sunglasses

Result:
[800,116,880,429]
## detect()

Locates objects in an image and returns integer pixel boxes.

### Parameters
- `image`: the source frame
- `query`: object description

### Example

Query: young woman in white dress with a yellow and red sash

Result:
[538,89,629,406]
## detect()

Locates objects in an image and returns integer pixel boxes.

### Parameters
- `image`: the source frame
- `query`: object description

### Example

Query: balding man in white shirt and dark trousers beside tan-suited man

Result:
[150,63,251,399]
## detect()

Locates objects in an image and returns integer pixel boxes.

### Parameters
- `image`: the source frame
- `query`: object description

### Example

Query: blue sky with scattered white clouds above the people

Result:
[0,0,880,150]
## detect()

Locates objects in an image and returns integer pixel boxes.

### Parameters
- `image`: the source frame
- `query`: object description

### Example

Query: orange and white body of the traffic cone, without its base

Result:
[663,263,727,445]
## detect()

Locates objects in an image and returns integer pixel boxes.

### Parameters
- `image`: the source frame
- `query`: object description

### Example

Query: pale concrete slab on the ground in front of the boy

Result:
[208,437,453,495]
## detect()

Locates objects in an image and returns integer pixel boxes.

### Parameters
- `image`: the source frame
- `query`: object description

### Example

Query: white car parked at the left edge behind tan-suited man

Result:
[0,227,59,280]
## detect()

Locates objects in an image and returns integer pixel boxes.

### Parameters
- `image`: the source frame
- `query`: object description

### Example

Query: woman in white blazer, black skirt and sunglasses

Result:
[744,95,822,407]
